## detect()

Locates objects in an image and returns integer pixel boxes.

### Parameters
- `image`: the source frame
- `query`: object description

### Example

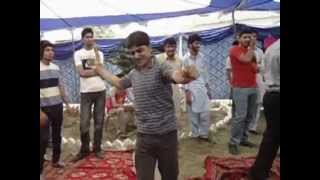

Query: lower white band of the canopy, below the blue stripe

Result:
[42,11,280,42]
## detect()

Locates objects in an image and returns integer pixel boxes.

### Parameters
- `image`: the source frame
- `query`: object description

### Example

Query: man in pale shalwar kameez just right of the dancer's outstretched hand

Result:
[183,34,210,141]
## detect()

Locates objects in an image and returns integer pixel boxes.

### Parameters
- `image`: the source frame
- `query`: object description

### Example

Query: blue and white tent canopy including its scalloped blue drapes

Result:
[40,0,280,60]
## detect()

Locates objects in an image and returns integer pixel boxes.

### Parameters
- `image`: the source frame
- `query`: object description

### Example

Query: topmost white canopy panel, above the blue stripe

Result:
[40,0,211,18]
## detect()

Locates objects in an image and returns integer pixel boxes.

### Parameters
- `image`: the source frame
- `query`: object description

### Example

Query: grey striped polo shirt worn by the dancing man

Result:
[120,57,177,135]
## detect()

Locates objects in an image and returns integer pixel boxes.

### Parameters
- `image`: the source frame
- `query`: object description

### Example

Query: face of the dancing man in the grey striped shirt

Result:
[129,45,152,67]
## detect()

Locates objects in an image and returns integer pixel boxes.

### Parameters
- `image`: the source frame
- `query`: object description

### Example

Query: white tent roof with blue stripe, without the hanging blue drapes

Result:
[40,0,280,43]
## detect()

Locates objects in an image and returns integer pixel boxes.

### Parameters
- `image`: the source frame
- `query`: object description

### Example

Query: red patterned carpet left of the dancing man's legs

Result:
[44,151,136,180]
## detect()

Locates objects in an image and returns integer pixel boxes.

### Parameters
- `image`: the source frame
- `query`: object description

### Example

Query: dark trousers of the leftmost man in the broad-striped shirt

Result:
[40,104,63,173]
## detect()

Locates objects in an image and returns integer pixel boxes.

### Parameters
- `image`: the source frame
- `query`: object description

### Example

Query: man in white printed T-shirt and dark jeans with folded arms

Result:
[74,28,106,161]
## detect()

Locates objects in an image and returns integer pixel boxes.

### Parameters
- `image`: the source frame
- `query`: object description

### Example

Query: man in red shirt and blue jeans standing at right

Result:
[229,30,257,155]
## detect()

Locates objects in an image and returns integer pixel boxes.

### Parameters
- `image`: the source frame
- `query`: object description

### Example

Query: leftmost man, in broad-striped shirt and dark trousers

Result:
[40,40,70,174]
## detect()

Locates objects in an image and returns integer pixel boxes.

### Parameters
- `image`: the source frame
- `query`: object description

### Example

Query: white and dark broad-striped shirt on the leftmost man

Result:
[40,61,62,107]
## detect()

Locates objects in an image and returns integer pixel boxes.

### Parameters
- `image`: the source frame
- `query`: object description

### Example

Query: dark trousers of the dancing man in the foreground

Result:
[135,131,179,180]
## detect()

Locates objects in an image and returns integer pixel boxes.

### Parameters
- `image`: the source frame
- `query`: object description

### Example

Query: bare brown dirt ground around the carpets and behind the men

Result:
[49,111,265,180]
